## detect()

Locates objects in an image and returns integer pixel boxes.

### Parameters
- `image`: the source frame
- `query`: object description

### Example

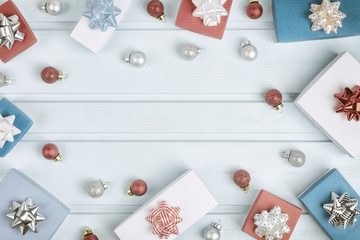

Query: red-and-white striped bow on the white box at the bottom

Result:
[146,201,182,239]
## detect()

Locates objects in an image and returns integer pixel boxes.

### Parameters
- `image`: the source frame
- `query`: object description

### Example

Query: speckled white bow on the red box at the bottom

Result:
[254,207,290,240]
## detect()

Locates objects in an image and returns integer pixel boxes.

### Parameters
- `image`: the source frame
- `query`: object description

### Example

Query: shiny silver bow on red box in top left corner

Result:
[0,13,25,50]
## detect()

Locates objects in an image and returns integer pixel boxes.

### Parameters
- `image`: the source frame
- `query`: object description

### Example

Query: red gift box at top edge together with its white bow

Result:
[175,0,232,39]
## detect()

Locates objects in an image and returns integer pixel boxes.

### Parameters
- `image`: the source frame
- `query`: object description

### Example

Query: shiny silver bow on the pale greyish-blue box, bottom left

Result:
[6,198,45,235]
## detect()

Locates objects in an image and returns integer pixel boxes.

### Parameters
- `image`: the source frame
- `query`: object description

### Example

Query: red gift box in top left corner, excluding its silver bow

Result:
[0,0,37,63]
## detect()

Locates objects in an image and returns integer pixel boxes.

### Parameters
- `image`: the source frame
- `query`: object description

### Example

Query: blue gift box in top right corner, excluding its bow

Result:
[272,0,360,42]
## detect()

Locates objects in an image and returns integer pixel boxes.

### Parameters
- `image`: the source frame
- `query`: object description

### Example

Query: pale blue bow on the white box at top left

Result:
[83,0,121,32]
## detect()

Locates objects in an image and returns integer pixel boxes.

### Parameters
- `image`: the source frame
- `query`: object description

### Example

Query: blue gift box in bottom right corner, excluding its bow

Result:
[299,168,360,240]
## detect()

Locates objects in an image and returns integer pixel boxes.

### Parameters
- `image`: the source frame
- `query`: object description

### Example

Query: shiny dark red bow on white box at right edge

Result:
[334,86,360,122]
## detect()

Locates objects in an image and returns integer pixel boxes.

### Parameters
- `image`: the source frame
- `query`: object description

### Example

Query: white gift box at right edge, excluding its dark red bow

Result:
[295,52,360,157]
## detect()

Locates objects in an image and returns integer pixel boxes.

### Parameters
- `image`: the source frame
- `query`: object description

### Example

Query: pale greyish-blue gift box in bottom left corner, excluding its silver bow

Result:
[0,169,70,240]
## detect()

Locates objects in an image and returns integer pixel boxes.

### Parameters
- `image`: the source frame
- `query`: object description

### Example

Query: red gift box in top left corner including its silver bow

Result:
[0,0,37,63]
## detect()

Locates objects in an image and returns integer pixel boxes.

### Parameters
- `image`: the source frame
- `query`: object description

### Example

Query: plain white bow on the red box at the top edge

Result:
[192,0,228,26]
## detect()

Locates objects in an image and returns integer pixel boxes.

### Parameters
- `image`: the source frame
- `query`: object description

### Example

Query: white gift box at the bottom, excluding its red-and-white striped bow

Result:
[115,170,218,240]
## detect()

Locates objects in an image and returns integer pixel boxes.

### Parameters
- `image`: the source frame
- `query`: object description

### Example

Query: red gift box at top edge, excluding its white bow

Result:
[175,0,232,39]
